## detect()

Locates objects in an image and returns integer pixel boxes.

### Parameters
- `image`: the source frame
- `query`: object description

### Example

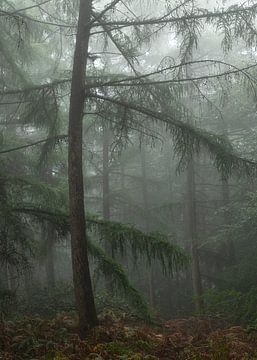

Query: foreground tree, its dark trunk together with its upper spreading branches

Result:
[1,0,256,335]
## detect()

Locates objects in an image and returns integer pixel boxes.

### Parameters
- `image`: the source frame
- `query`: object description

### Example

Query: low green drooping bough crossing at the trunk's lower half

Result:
[11,206,190,276]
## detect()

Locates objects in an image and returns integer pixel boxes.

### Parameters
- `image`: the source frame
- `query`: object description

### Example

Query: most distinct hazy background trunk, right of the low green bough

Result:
[187,159,203,312]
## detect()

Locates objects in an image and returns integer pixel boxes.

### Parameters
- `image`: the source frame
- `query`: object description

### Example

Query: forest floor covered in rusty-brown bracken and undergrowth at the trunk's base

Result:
[0,315,257,360]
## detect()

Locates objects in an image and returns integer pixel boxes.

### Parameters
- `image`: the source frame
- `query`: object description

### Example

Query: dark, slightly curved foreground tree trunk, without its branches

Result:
[68,0,97,337]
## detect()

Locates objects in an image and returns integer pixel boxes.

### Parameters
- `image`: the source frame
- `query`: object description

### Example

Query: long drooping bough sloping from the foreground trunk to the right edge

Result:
[88,93,257,177]
